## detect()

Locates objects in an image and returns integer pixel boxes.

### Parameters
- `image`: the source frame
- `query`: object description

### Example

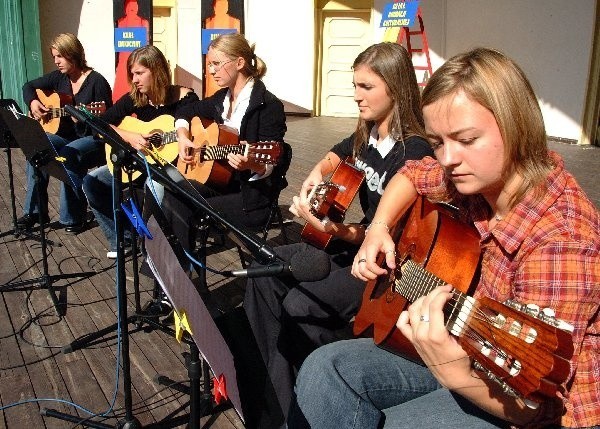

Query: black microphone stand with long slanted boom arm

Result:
[43,105,279,429]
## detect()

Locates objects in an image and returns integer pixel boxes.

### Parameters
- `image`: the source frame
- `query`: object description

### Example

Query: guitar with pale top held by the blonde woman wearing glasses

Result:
[177,117,282,188]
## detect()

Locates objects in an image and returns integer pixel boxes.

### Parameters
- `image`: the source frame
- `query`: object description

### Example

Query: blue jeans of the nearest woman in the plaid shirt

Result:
[288,338,507,429]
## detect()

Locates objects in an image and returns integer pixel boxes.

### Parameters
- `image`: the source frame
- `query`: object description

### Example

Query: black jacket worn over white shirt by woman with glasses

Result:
[175,80,291,210]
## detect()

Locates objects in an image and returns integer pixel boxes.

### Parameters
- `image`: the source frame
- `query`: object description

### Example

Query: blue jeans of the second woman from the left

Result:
[83,165,164,252]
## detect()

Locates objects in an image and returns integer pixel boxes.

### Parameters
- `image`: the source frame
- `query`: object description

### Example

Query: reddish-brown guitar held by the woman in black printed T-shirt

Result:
[300,158,365,249]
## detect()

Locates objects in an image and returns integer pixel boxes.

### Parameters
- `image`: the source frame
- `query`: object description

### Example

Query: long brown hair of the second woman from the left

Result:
[127,45,171,107]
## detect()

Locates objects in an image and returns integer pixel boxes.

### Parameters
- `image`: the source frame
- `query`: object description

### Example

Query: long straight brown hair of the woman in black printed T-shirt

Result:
[352,42,425,158]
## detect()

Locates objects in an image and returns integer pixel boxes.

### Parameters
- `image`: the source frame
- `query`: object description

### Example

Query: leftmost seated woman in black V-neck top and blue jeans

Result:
[17,33,112,234]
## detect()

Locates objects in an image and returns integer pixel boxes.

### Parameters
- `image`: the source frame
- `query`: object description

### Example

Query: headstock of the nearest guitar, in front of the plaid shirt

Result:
[447,297,573,402]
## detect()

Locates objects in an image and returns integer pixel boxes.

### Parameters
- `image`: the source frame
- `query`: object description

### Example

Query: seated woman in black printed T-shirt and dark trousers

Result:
[244,43,432,427]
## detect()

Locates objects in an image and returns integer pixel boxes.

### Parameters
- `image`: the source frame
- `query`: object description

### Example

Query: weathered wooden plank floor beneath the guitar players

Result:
[0,117,600,429]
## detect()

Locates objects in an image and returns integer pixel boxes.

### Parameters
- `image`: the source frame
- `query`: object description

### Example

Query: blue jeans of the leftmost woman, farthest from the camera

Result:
[23,133,105,225]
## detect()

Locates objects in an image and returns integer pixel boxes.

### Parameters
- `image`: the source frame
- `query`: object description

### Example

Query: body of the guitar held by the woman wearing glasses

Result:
[177,117,239,188]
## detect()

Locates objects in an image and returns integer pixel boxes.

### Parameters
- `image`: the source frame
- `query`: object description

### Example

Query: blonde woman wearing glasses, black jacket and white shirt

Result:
[163,34,291,249]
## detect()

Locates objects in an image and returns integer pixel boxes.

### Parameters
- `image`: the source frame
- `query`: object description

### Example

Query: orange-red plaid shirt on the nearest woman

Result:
[400,152,600,427]
